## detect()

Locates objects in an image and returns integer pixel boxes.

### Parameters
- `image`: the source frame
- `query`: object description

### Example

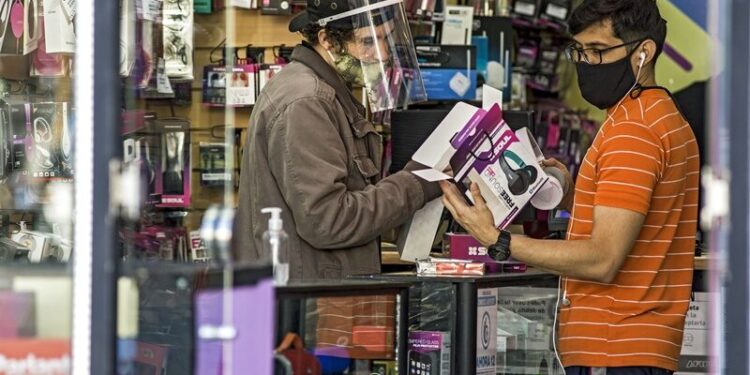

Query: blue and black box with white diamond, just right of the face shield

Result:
[415,45,477,100]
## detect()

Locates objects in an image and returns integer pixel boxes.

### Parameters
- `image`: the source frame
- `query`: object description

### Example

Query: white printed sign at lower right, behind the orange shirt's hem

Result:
[675,293,716,375]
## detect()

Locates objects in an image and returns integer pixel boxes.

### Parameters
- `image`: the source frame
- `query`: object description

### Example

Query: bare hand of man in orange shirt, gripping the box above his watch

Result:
[440,181,500,246]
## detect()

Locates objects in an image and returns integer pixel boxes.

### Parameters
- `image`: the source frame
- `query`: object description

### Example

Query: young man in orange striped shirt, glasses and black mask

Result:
[441,0,700,375]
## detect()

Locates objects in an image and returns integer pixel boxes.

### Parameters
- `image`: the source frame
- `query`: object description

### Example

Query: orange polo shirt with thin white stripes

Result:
[559,89,700,371]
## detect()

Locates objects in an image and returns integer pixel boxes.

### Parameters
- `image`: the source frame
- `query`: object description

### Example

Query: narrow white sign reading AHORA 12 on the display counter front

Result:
[476,288,497,375]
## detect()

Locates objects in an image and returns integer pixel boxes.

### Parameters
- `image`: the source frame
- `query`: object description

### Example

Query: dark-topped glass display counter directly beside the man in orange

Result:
[356,270,559,374]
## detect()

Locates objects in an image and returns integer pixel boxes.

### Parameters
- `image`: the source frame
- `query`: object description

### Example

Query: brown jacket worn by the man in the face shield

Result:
[233,45,440,279]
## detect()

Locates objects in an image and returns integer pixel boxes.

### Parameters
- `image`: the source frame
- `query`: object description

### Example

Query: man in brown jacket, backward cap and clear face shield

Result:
[233,0,440,279]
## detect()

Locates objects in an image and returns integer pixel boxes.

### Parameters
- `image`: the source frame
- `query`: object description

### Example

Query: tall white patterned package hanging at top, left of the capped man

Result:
[162,0,193,79]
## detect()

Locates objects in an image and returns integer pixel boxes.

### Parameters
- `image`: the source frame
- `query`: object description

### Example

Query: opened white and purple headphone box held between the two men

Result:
[399,86,550,261]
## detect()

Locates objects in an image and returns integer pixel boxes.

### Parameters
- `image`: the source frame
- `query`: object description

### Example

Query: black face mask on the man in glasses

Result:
[576,49,635,109]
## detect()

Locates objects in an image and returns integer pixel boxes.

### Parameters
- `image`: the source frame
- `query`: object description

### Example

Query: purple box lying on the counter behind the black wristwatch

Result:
[443,233,526,273]
